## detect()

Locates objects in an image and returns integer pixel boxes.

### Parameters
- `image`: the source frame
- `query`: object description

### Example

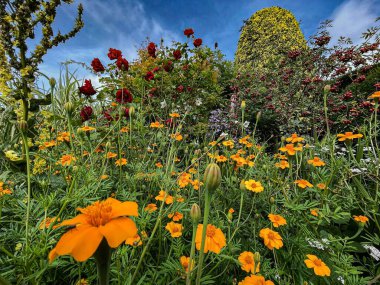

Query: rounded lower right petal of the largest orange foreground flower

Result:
[99,217,137,248]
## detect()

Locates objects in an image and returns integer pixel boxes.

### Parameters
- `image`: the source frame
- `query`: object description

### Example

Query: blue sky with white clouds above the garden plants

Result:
[41,0,380,80]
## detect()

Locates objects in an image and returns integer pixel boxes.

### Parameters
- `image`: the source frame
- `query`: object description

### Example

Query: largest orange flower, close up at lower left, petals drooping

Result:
[49,198,138,262]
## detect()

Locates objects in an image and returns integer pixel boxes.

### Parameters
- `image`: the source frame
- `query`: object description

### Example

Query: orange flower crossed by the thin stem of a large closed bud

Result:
[195,224,226,254]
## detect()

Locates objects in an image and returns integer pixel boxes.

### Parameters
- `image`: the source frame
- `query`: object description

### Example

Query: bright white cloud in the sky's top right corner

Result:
[329,0,379,44]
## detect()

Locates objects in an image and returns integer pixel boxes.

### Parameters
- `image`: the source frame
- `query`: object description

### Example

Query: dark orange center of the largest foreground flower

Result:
[82,201,112,227]
